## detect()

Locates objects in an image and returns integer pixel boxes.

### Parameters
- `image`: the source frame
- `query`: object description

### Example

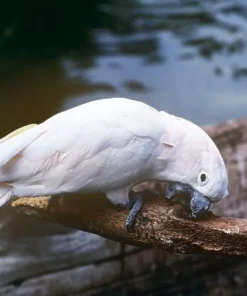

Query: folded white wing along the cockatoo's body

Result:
[0,98,160,196]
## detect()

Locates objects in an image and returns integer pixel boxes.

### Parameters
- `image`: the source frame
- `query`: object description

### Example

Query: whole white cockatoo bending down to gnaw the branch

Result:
[0,98,228,229]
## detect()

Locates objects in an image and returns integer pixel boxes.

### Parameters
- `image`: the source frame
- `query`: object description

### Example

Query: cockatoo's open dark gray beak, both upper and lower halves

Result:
[166,182,211,218]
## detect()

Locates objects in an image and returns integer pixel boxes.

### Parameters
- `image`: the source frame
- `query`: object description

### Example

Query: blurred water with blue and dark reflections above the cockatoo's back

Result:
[0,0,247,135]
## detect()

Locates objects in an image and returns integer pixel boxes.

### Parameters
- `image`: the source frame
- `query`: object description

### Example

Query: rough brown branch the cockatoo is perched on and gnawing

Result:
[11,194,247,255]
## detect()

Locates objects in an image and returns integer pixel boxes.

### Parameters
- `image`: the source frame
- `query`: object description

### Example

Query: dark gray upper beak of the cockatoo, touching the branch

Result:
[190,191,211,218]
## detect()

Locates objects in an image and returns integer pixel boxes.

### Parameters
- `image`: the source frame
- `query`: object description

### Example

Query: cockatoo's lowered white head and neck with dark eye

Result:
[157,112,228,217]
